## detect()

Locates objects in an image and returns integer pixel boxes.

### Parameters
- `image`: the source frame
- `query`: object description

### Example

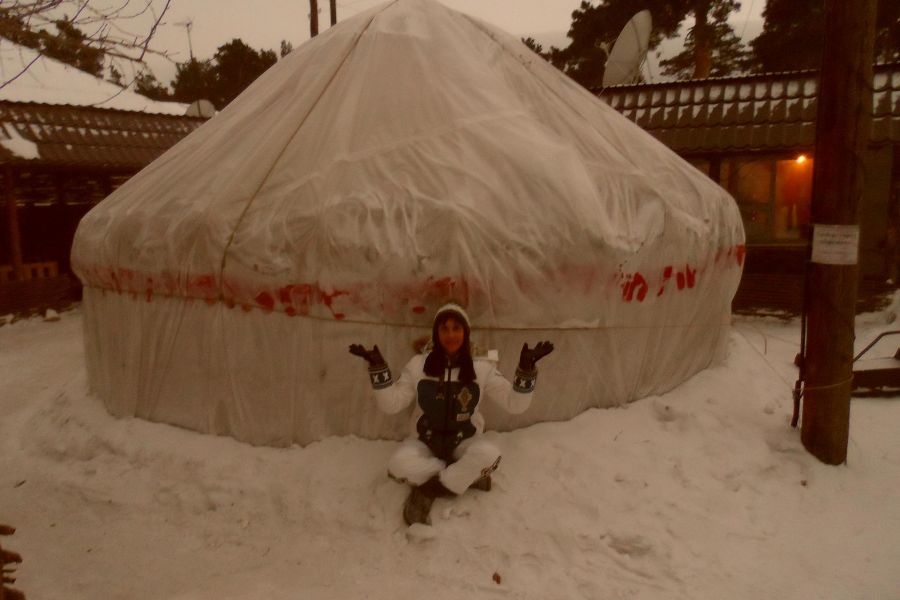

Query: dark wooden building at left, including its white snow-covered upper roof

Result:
[0,37,205,315]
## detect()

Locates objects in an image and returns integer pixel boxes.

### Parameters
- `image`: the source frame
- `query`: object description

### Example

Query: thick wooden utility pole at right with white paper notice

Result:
[800,0,876,465]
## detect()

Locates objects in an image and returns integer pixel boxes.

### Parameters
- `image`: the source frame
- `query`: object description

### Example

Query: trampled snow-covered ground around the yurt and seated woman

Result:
[0,302,900,600]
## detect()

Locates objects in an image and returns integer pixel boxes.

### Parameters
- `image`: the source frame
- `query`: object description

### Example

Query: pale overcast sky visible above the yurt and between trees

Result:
[148,0,765,83]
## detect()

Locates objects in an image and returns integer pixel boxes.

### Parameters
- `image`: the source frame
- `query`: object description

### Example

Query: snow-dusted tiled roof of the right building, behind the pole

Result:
[600,63,900,153]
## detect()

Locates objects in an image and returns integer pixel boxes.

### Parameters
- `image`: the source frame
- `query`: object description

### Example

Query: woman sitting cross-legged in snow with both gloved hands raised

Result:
[350,304,553,525]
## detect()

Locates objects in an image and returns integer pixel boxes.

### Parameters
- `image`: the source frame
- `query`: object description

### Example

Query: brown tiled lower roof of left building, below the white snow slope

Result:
[0,101,205,170]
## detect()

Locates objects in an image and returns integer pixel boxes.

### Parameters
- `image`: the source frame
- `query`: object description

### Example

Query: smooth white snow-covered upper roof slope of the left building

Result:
[0,38,188,115]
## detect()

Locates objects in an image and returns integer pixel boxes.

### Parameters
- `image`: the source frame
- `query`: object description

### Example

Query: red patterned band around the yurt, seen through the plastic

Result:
[79,244,746,320]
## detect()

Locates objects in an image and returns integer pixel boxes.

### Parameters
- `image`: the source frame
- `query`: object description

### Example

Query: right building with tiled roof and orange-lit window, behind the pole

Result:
[598,63,900,311]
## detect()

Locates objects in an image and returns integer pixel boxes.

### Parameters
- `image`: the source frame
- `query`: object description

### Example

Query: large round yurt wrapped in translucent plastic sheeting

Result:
[72,0,744,445]
